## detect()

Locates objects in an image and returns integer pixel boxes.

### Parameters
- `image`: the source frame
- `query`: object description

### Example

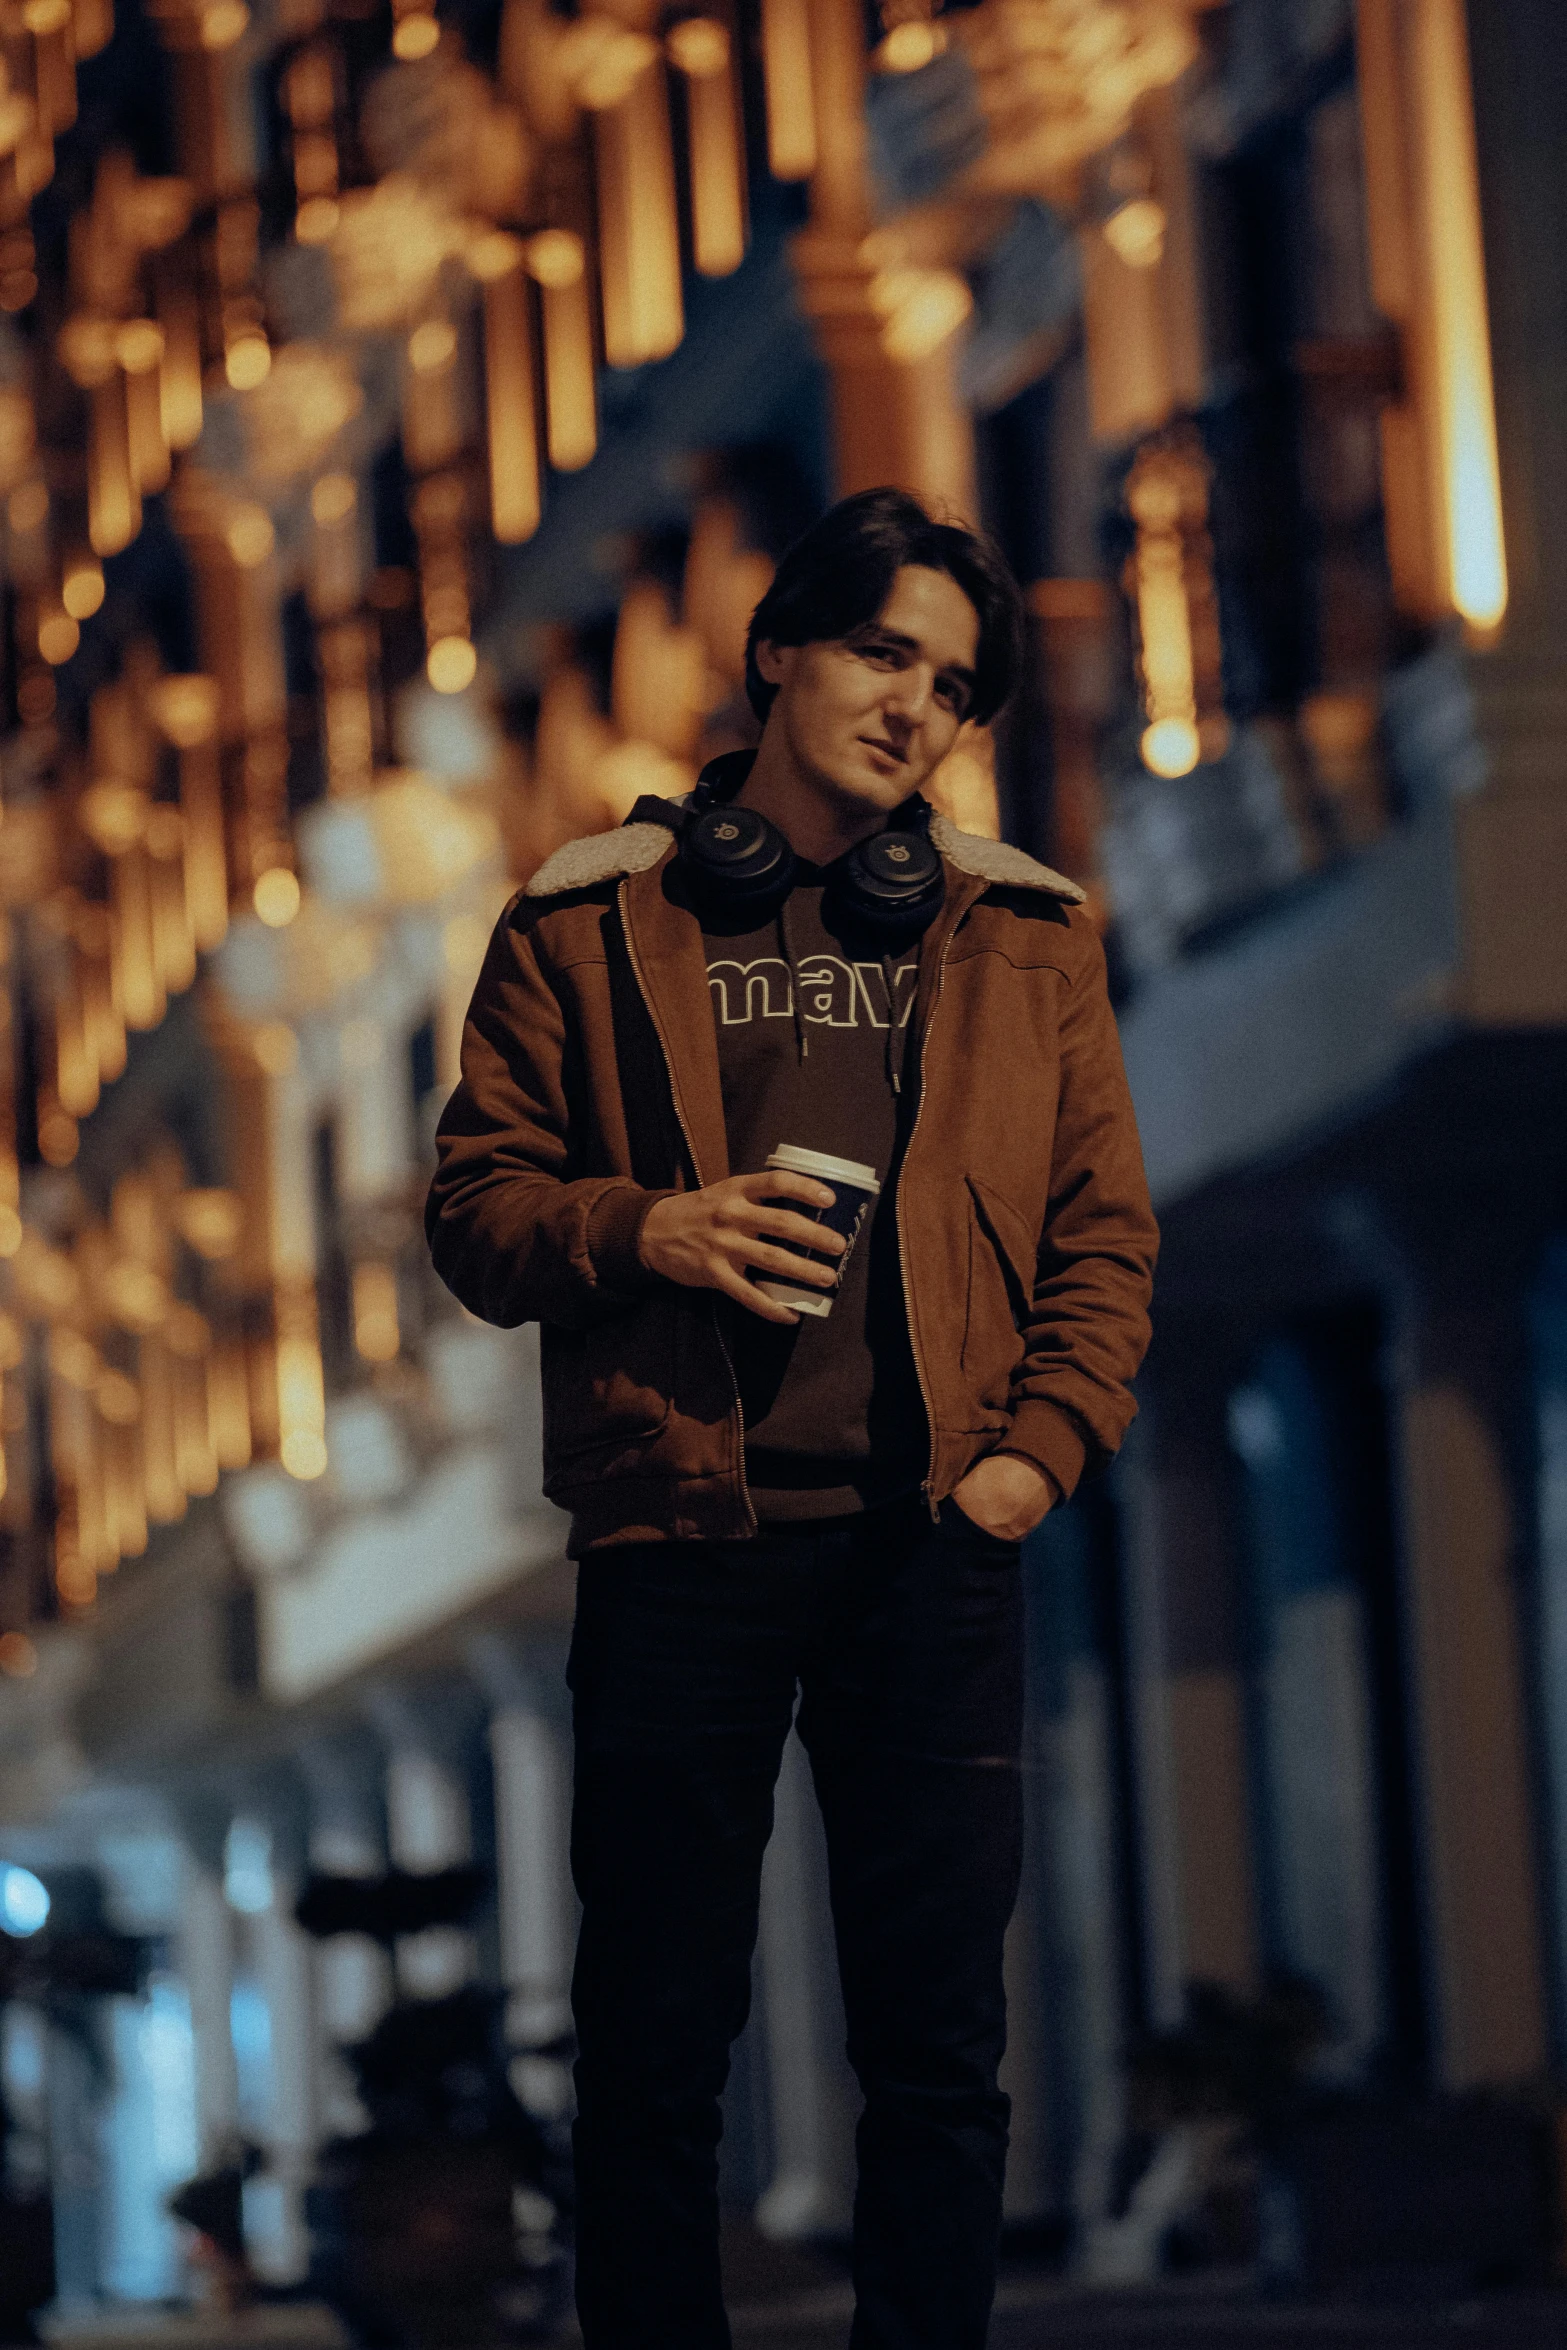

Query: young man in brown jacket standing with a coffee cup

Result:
[428,491,1156,2350]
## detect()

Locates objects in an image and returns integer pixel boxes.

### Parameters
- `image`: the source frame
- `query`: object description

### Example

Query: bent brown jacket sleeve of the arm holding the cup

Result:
[425,898,665,1330]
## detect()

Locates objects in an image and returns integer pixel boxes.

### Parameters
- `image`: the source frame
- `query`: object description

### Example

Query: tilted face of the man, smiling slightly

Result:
[756,564,980,811]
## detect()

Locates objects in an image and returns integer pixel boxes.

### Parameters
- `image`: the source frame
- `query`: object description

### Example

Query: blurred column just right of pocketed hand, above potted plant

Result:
[1123,1316,1257,2026]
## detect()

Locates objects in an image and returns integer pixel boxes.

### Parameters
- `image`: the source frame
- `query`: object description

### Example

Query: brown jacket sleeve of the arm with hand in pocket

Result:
[998,933,1158,1495]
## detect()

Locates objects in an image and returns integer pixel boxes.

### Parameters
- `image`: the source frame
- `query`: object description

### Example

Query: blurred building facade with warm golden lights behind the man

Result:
[0,0,1567,2305]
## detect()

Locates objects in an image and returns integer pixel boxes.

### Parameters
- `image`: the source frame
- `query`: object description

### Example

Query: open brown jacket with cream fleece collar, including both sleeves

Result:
[425,815,1158,1556]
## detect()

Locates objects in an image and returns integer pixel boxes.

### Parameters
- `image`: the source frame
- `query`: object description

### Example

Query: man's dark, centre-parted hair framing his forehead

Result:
[745,489,1022,724]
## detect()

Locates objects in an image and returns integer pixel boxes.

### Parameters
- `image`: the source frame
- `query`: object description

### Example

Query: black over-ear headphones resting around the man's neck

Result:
[627,752,947,938]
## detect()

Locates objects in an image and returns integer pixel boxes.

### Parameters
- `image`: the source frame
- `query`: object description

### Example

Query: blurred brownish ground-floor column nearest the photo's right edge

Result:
[1393,1210,1548,2089]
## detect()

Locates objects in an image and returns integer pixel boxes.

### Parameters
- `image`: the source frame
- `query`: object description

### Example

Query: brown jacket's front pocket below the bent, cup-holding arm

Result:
[540,1295,679,1492]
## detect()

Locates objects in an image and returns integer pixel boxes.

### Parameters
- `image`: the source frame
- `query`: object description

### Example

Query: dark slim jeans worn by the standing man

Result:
[571,1502,1022,2350]
